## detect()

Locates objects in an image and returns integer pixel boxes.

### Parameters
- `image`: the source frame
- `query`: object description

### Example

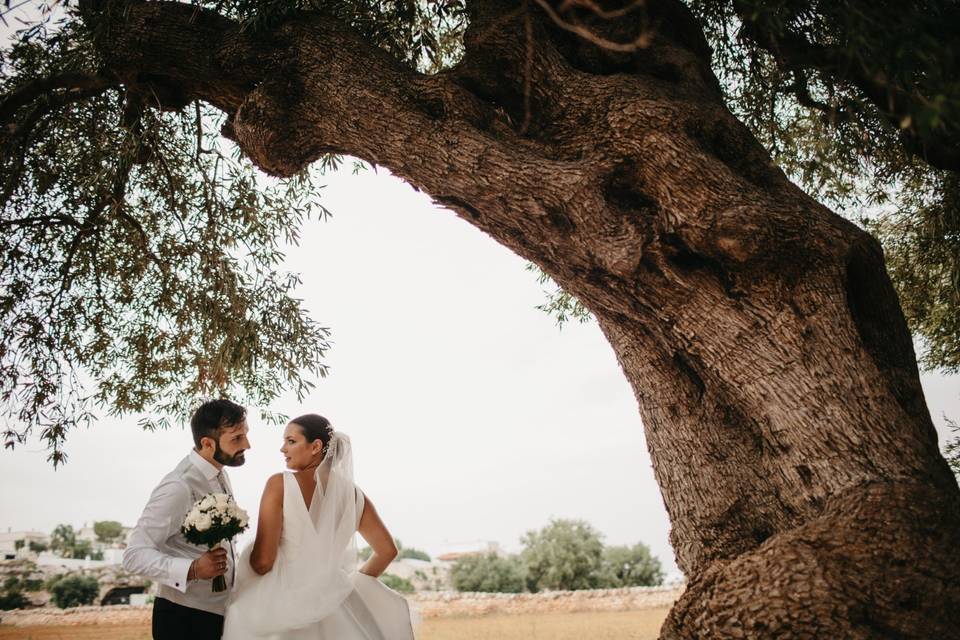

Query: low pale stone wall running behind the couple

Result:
[0,585,683,627]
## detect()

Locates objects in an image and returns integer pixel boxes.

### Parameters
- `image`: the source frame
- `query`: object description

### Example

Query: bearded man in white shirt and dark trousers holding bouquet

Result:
[123,400,250,640]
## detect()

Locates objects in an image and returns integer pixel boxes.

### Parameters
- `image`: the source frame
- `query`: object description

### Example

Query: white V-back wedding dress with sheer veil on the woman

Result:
[223,432,414,640]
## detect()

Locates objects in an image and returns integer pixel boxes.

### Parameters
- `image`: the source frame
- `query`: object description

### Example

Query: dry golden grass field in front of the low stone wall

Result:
[0,608,669,640]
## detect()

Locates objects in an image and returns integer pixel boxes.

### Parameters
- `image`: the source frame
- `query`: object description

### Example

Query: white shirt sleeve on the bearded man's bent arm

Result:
[123,480,199,592]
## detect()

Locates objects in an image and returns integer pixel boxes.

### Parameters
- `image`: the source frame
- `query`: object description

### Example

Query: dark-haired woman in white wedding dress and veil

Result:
[223,414,413,640]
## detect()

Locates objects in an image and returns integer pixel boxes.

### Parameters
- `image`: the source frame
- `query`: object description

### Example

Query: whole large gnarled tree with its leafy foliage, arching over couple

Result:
[0,0,960,638]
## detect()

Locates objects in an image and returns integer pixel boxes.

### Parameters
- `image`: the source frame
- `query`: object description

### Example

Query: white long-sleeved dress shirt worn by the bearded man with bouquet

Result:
[123,450,234,615]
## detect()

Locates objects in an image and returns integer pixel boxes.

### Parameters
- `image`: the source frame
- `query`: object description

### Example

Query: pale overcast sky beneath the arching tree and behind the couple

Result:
[0,165,960,570]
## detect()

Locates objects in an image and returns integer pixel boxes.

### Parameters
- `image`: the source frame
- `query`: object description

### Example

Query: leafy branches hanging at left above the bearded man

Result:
[0,12,329,465]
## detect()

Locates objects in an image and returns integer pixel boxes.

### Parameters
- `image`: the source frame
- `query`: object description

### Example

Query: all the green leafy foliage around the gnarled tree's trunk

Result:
[0,0,960,464]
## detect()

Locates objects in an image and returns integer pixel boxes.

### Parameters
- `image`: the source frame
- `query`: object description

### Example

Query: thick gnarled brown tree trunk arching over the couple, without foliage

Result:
[88,0,960,638]
